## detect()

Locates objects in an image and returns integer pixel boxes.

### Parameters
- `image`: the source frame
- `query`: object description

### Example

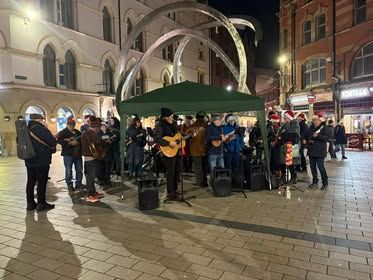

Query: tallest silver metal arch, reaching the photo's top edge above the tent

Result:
[116,1,247,97]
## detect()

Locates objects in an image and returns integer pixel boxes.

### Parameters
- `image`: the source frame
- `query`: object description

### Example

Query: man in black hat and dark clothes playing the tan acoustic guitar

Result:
[154,108,180,200]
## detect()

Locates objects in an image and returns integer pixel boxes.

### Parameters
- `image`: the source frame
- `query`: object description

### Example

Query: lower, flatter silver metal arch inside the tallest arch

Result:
[117,29,244,100]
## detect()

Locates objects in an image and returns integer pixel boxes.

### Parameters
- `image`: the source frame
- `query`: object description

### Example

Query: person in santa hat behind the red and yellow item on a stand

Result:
[278,110,300,184]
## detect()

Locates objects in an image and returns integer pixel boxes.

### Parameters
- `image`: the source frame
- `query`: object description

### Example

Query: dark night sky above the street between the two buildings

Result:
[209,0,279,68]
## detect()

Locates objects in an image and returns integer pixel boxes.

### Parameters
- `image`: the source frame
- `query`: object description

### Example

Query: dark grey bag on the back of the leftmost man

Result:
[15,120,36,160]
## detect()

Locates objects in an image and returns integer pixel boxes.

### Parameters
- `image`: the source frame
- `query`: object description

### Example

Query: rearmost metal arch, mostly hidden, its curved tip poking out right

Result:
[173,16,263,84]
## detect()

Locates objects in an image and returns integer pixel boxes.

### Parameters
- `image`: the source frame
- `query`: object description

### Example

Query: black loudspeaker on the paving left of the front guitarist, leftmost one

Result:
[137,178,159,210]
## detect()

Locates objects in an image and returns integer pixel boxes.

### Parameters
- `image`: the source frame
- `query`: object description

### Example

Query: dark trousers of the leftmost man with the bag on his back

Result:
[26,165,49,204]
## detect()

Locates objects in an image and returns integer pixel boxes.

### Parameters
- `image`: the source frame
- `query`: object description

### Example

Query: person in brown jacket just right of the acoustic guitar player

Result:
[187,112,208,188]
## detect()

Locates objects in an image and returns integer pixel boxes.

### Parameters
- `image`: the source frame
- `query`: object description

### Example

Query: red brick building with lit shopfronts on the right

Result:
[279,0,373,133]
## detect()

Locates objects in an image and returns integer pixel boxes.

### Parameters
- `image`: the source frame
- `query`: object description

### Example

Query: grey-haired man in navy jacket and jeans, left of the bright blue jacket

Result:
[206,114,225,182]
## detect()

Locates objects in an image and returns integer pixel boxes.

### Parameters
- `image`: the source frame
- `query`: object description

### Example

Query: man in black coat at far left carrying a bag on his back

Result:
[25,114,57,211]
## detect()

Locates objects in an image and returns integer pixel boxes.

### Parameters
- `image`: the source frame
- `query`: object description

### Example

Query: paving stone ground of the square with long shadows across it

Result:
[0,152,373,280]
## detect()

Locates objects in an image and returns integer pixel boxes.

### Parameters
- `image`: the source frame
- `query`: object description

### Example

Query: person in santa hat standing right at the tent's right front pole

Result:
[267,114,280,174]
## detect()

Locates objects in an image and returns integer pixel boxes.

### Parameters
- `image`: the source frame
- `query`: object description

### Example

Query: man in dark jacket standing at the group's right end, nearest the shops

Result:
[304,115,330,190]
